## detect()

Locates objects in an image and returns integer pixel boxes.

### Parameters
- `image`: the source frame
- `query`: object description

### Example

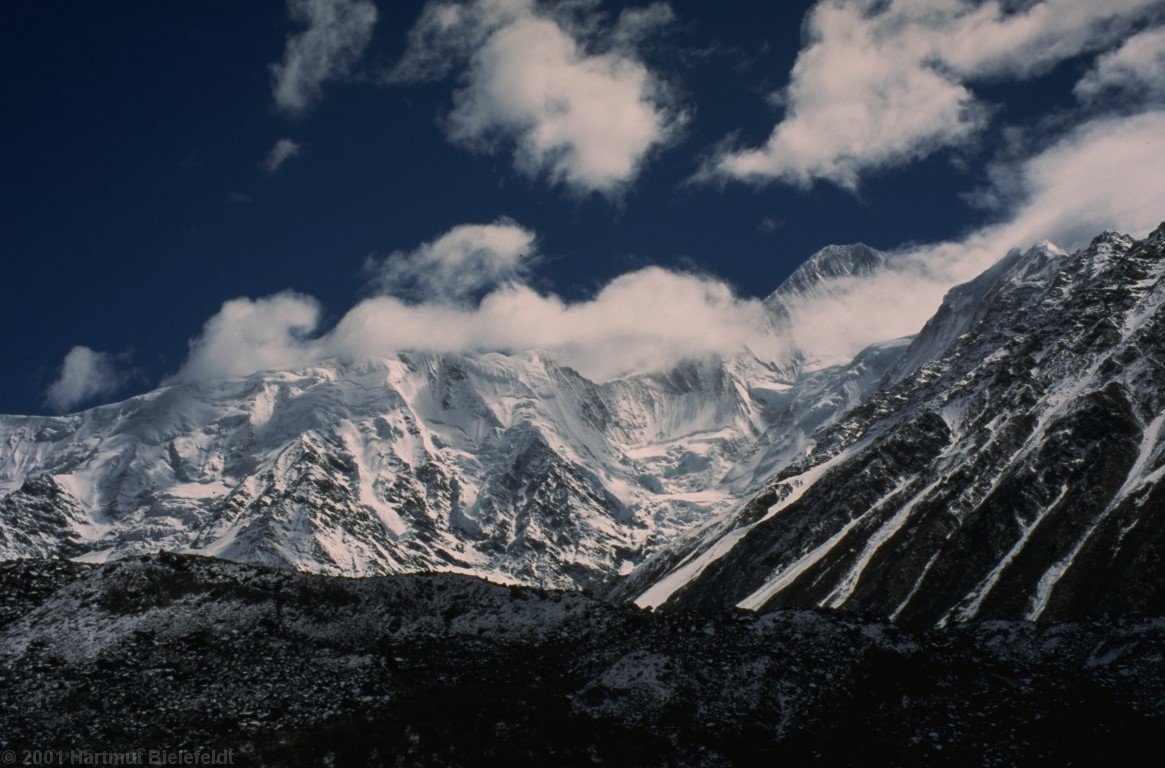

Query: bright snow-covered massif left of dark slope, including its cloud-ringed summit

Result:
[0,246,904,587]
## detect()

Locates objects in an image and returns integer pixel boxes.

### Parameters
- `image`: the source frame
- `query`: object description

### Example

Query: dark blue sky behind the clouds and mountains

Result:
[0,0,1141,413]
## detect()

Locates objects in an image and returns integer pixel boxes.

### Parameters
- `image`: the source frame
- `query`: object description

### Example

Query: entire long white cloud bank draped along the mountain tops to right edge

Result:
[161,111,1165,381]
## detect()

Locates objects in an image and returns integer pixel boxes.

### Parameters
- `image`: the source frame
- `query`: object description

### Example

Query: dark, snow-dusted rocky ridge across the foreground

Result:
[0,555,1165,768]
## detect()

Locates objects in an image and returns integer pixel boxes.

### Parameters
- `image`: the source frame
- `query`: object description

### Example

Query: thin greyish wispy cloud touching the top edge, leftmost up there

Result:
[271,0,376,113]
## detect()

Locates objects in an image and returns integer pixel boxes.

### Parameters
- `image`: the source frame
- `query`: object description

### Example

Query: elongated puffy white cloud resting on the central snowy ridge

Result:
[325,268,779,381]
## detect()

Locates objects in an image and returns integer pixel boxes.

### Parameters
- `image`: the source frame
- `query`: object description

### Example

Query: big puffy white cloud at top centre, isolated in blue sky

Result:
[391,0,682,195]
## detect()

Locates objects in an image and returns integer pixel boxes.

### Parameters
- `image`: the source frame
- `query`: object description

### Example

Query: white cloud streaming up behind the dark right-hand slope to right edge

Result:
[790,111,1165,370]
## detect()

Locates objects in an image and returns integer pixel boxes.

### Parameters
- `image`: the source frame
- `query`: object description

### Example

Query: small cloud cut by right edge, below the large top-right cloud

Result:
[1075,27,1165,101]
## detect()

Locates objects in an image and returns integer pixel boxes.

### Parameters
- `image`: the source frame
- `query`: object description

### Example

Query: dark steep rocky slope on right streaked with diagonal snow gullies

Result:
[638,227,1165,625]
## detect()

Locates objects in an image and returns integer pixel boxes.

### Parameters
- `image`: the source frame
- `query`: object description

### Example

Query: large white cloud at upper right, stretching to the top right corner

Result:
[702,0,1163,189]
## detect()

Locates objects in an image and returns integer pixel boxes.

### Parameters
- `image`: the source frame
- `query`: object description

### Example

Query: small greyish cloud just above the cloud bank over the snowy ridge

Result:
[365,219,536,303]
